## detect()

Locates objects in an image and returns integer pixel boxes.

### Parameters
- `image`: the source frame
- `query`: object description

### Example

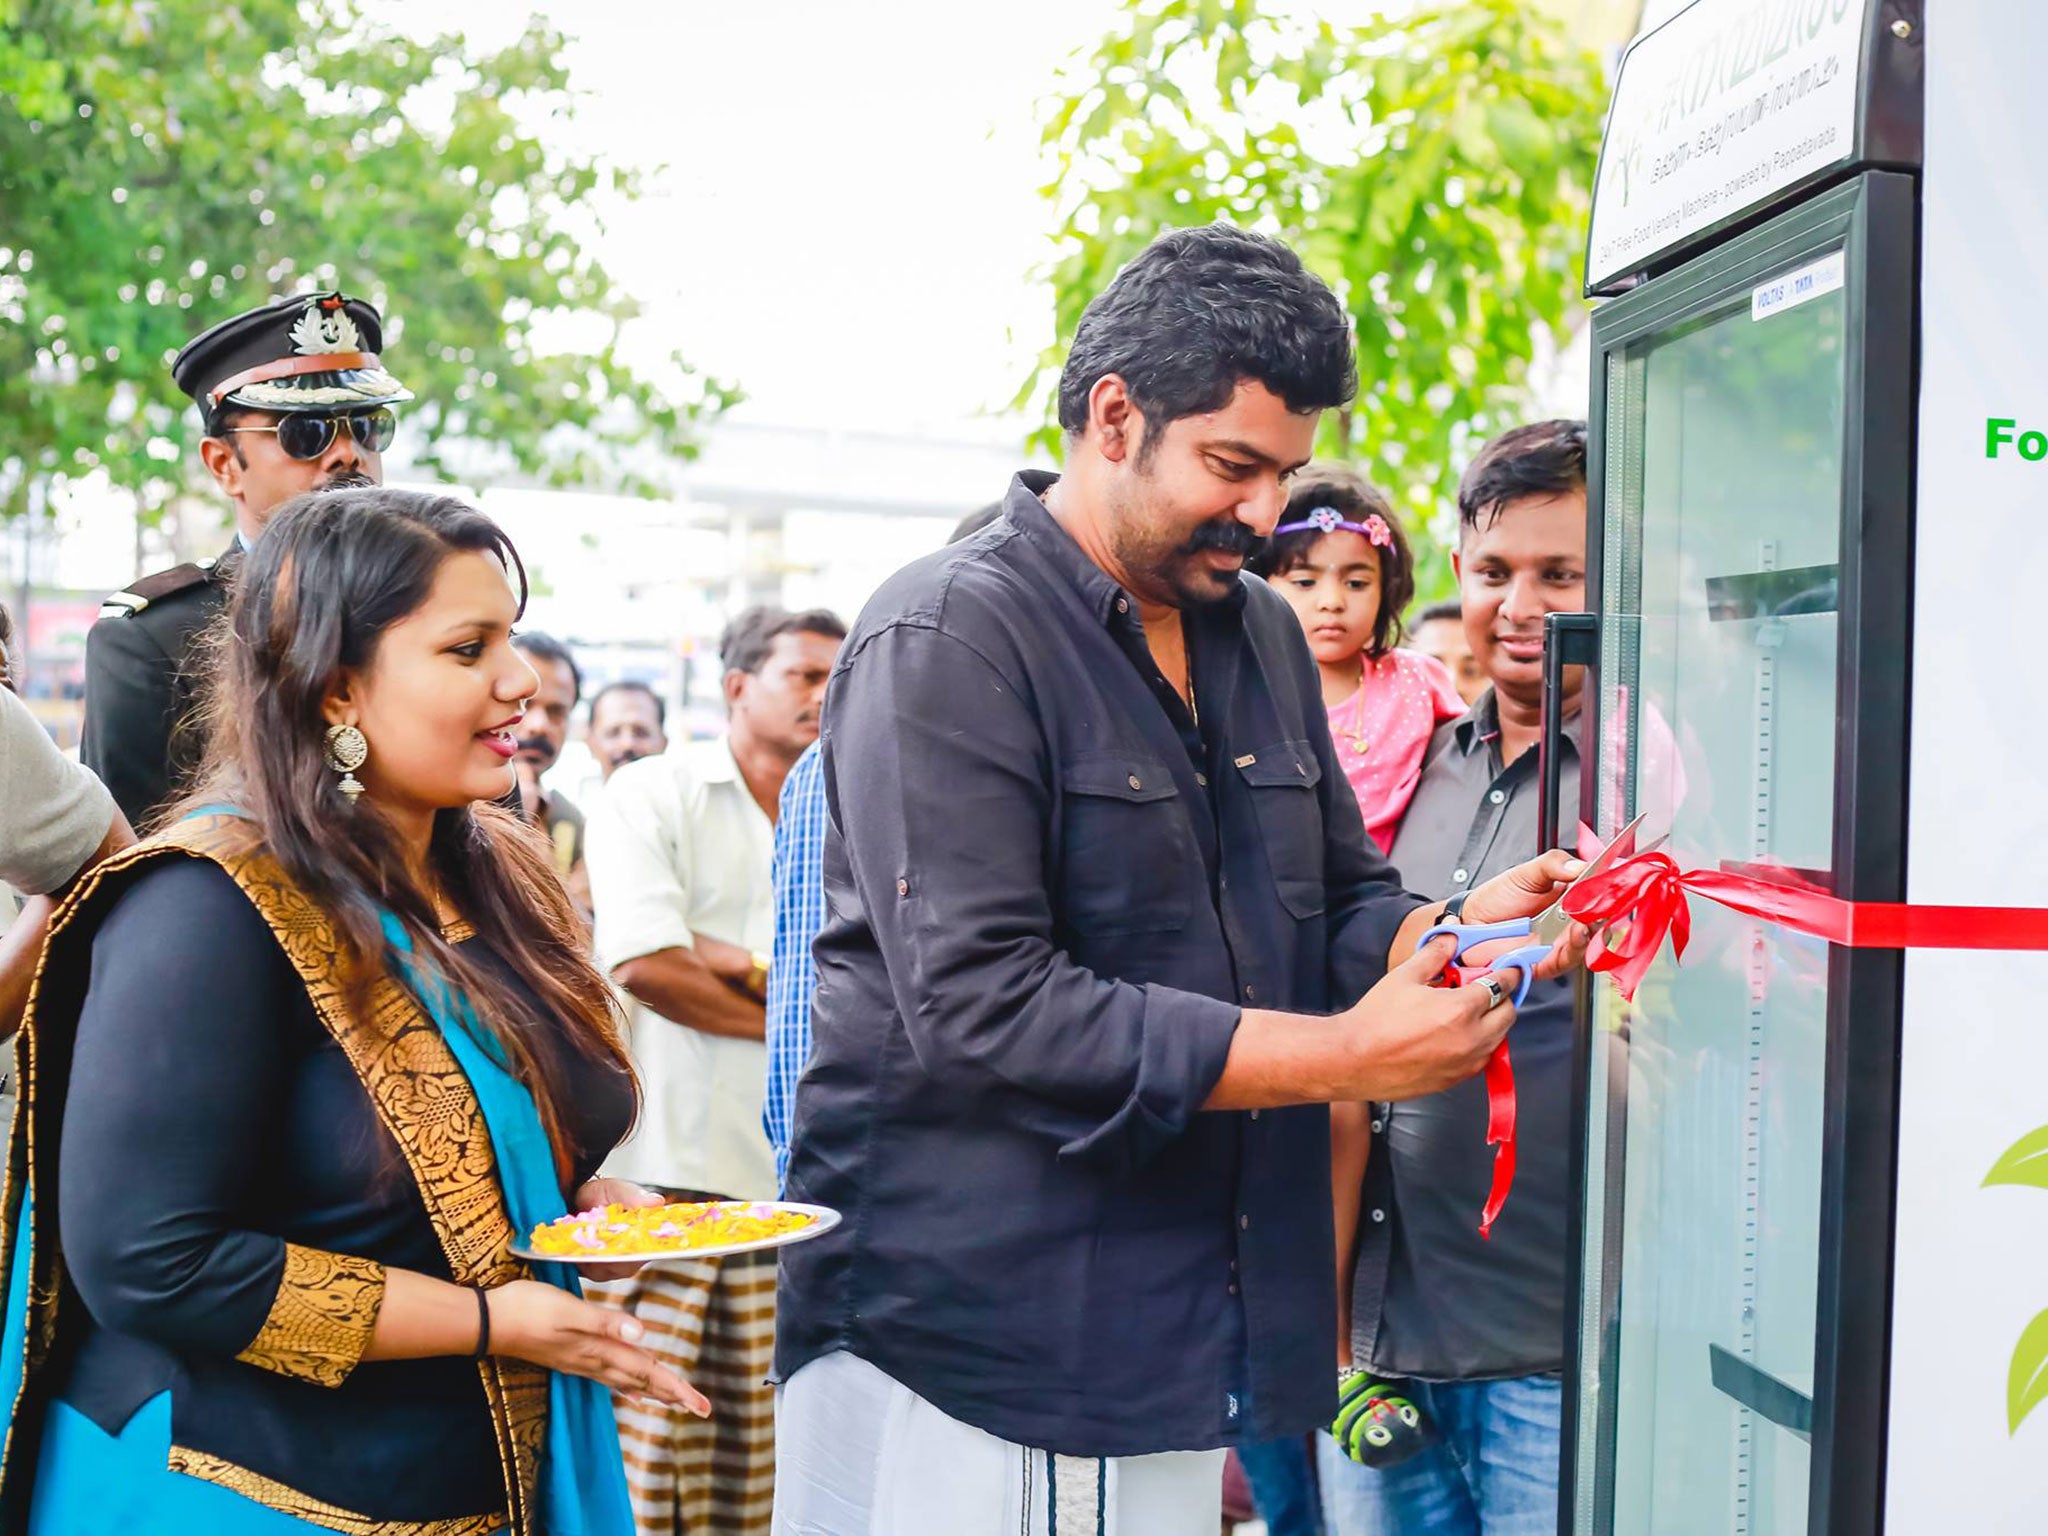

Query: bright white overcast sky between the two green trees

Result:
[385,0,1138,438]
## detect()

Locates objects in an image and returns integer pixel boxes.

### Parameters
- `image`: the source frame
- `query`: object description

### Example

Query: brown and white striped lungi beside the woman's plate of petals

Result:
[586,1251,774,1536]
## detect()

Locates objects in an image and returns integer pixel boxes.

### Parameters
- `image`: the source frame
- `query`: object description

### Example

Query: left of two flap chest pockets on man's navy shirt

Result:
[1053,752,1206,934]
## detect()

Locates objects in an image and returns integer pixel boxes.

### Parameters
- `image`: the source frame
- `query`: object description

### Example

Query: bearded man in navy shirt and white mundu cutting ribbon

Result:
[774,225,1583,1536]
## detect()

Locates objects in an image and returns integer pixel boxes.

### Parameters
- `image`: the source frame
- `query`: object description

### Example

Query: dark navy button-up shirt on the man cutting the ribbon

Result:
[776,473,1421,1456]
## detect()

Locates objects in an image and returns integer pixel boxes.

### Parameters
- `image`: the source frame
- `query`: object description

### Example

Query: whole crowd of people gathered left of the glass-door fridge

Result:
[0,225,1587,1536]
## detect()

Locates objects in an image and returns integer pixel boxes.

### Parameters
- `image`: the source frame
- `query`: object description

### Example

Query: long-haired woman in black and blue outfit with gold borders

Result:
[0,489,705,1536]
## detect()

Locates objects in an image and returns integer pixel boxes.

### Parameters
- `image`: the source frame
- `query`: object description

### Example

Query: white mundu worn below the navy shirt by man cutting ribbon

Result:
[774,1350,1223,1536]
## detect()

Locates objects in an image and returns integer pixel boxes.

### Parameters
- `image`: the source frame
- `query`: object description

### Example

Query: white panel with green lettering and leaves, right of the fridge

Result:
[1886,0,2048,1536]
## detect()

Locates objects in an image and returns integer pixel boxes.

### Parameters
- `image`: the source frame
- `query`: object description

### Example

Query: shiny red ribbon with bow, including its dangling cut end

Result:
[1479,852,2048,1237]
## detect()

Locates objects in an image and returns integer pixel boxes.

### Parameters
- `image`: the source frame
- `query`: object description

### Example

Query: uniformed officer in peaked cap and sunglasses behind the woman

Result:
[80,293,412,827]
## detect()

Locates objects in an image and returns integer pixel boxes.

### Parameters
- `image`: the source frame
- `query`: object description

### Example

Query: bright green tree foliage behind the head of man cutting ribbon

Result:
[1020,0,1606,581]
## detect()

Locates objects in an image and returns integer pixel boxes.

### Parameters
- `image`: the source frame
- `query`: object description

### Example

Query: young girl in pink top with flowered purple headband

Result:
[1251,465,1464,852]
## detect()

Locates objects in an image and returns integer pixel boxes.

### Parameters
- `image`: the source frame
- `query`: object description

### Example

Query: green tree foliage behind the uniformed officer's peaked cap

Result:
[0,0,733,516]
